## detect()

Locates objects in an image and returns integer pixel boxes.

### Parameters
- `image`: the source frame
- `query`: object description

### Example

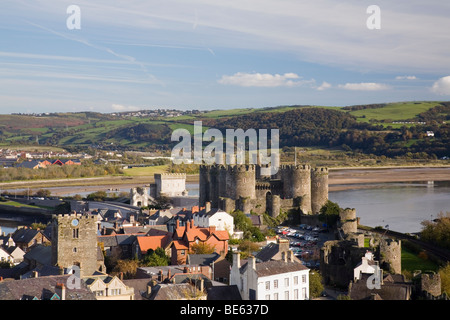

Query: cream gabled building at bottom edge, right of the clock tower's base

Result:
[83,275,134,300]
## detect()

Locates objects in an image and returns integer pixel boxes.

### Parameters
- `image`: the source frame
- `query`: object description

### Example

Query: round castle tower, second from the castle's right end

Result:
[289,165,312,214]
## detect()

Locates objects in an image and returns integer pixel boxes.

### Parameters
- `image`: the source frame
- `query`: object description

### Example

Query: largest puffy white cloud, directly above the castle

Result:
[218,72,315,87]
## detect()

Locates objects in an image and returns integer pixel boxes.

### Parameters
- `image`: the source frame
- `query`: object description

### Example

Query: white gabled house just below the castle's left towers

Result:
[194,203,234,236]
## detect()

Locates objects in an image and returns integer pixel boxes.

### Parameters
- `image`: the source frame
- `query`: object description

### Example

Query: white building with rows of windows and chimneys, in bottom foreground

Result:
[230,251,309,300]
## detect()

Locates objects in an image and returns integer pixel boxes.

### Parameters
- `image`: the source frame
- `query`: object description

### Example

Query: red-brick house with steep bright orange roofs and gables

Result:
[171,220,229,264]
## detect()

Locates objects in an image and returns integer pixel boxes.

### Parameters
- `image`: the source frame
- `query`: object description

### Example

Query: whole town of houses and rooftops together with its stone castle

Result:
[0,164,448,300]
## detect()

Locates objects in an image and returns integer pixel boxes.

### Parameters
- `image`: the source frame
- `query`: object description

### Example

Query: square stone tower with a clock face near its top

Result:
[52,213,97,276]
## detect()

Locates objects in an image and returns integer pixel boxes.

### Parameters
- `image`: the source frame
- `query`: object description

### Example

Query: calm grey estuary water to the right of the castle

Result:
[329,181,450,233]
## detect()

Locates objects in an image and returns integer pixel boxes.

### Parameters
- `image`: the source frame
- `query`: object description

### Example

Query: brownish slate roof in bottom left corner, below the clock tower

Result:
[0,275,95,300]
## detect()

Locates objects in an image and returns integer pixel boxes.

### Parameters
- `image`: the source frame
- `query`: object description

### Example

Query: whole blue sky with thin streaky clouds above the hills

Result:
[0,0,450,113]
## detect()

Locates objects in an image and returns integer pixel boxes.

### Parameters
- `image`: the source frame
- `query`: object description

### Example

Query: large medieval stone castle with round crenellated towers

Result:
[199,164,328,217]
